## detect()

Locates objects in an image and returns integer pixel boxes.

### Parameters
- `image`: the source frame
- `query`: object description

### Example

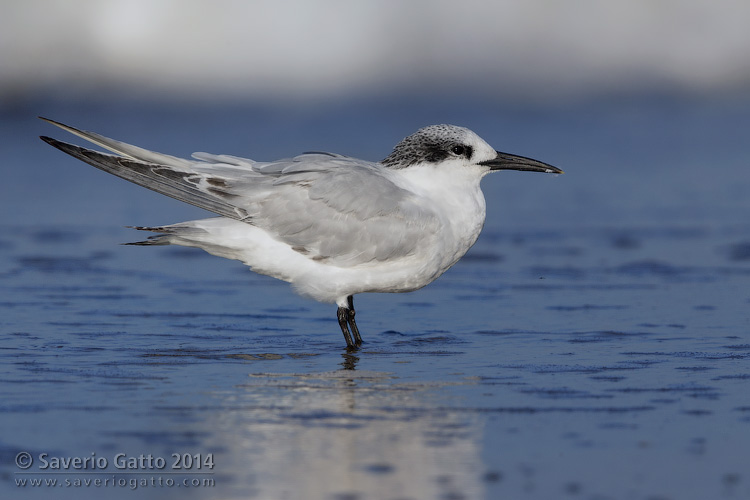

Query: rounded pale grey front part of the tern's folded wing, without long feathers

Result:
[247,156,439,266]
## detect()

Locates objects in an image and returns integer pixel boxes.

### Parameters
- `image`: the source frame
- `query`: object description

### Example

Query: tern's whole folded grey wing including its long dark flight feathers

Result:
[42,120,439,266]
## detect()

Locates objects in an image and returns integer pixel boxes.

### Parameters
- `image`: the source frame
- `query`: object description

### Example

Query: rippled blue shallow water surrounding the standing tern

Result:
[0,94,750,500]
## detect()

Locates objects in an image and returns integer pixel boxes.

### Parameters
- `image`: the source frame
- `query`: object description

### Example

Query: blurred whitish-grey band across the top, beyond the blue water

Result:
[0,0,750,103]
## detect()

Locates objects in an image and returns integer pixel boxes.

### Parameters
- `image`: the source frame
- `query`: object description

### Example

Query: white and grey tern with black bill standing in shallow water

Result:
[39,117,563,351]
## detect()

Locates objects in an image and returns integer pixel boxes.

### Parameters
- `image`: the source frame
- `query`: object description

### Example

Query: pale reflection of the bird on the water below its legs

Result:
[217,366,485,498]
